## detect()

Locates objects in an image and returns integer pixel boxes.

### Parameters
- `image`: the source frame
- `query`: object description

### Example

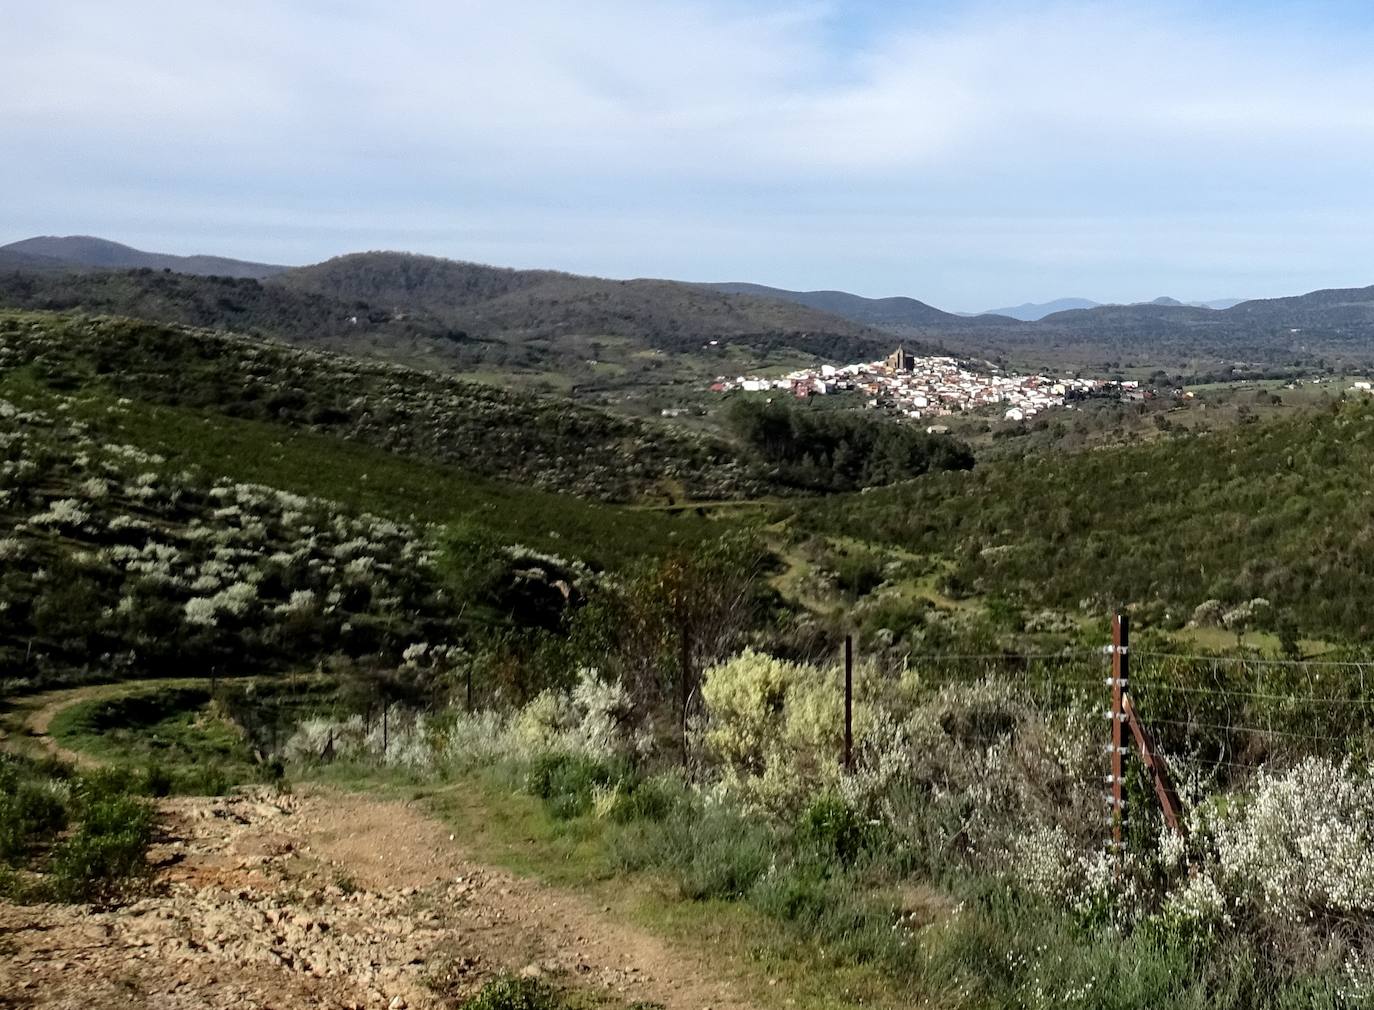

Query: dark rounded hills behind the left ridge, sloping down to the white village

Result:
[0,236,923,375]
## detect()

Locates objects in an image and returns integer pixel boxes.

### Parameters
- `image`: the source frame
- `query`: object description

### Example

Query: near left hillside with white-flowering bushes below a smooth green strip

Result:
[0,315,732,690]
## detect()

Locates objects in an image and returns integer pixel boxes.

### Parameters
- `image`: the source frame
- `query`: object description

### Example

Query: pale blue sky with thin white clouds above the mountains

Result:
[0,0,1374,311]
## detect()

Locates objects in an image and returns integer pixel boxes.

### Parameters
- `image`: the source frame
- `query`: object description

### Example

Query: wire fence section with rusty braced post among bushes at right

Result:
[895,616,1374,845]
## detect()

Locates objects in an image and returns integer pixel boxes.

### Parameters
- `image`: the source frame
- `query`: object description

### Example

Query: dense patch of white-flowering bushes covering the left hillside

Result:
[0,387,452,687]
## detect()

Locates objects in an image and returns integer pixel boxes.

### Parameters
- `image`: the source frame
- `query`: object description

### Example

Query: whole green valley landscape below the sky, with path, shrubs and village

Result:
[8,239,1374,1010]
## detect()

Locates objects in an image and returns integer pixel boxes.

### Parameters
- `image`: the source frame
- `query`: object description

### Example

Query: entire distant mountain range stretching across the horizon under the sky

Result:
[0,236,1374,376]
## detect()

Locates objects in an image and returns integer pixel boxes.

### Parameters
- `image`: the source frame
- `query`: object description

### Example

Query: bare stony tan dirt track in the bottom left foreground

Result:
[0,789,747,1010]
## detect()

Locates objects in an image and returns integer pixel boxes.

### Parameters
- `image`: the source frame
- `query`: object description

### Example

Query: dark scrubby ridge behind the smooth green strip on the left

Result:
[0,315,769,500]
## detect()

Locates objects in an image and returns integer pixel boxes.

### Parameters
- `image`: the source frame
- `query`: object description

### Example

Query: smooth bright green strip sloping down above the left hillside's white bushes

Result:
[0,362,727,565]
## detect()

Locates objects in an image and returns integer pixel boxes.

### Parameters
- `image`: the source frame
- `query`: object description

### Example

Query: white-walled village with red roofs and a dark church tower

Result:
[710,348,1126,420]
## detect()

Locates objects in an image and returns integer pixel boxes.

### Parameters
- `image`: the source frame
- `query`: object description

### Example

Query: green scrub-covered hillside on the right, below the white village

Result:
[797,400,1374,640]
